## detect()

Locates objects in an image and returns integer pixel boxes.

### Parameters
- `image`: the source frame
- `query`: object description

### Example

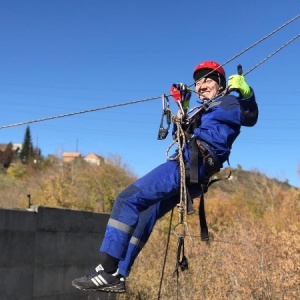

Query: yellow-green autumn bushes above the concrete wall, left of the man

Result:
[0,156,136,213]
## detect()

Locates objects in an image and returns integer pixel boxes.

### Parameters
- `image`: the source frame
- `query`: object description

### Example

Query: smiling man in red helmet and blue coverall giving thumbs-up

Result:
[72,61,258,292]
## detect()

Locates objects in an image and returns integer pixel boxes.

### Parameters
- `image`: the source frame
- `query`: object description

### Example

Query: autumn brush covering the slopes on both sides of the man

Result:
[0,127,300,300]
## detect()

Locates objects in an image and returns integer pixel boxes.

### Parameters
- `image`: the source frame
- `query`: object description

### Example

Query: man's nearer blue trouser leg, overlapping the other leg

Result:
[100,161,180,260]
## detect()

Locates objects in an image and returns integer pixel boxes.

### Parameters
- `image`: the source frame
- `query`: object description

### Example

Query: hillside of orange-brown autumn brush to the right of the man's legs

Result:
[118,169,300,300]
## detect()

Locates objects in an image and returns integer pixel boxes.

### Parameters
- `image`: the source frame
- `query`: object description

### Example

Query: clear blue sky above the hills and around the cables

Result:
[0,0,300,187]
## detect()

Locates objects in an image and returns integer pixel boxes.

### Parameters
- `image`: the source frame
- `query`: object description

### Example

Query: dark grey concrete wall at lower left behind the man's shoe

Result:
[0,207,116,300]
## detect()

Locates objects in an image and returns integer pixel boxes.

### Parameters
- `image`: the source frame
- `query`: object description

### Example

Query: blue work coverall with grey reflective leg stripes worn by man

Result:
[100,90,258,276]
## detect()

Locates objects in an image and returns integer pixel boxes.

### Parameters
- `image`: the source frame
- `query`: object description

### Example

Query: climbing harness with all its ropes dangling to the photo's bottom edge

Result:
[158,96,229,299]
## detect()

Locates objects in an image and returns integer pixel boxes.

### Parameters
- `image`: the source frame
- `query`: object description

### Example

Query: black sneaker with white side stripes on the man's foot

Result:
[72,265,126,293]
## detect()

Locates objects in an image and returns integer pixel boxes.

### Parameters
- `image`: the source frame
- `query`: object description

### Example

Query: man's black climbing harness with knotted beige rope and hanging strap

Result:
[167,98,221,240]
